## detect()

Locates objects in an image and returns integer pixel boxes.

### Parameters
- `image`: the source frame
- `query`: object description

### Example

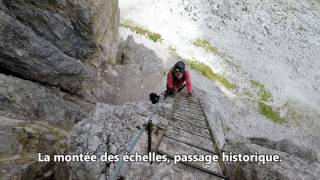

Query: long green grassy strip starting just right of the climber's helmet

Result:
[186,59,236,90]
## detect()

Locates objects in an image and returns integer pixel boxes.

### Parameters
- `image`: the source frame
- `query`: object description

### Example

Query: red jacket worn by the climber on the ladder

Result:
[167,71,192,94]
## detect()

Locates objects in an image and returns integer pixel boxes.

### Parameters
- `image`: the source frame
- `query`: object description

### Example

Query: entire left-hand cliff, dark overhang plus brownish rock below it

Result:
[0,0,119,179]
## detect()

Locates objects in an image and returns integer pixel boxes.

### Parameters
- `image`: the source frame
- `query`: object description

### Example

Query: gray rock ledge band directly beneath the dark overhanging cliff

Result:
[0,74,89,128]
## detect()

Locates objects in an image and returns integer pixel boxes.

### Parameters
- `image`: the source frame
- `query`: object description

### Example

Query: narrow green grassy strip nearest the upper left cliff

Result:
[121,21,161,42]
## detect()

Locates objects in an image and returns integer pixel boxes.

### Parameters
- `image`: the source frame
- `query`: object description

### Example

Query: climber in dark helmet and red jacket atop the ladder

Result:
[165,61,192,96]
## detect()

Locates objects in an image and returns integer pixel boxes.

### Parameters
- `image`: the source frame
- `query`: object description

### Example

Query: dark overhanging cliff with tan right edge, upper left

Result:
[0,0,119,96]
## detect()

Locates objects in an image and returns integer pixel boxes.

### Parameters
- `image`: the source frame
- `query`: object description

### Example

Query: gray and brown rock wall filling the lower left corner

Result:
[0,74,93,180]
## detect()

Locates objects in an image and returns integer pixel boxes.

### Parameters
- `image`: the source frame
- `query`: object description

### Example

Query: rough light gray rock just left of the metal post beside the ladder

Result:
[70,103,151,180]
